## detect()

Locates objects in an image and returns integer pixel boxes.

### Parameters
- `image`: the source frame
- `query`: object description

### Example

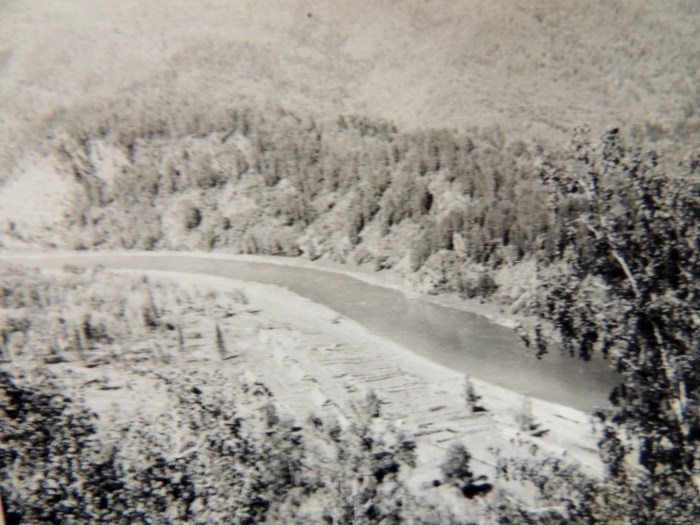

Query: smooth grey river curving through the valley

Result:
[4,252,619,412]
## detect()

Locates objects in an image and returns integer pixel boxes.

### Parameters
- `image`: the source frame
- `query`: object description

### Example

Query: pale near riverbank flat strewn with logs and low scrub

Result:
[0,254,600,517]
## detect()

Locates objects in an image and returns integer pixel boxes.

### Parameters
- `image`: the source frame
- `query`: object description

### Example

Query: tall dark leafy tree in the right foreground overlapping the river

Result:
[536,129,700,499]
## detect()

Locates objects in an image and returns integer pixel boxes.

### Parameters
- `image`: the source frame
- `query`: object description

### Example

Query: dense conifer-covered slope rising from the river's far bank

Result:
[55,101,558,296]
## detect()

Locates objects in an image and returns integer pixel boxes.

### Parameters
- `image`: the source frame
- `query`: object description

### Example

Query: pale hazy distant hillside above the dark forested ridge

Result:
[0,0,700,174]
